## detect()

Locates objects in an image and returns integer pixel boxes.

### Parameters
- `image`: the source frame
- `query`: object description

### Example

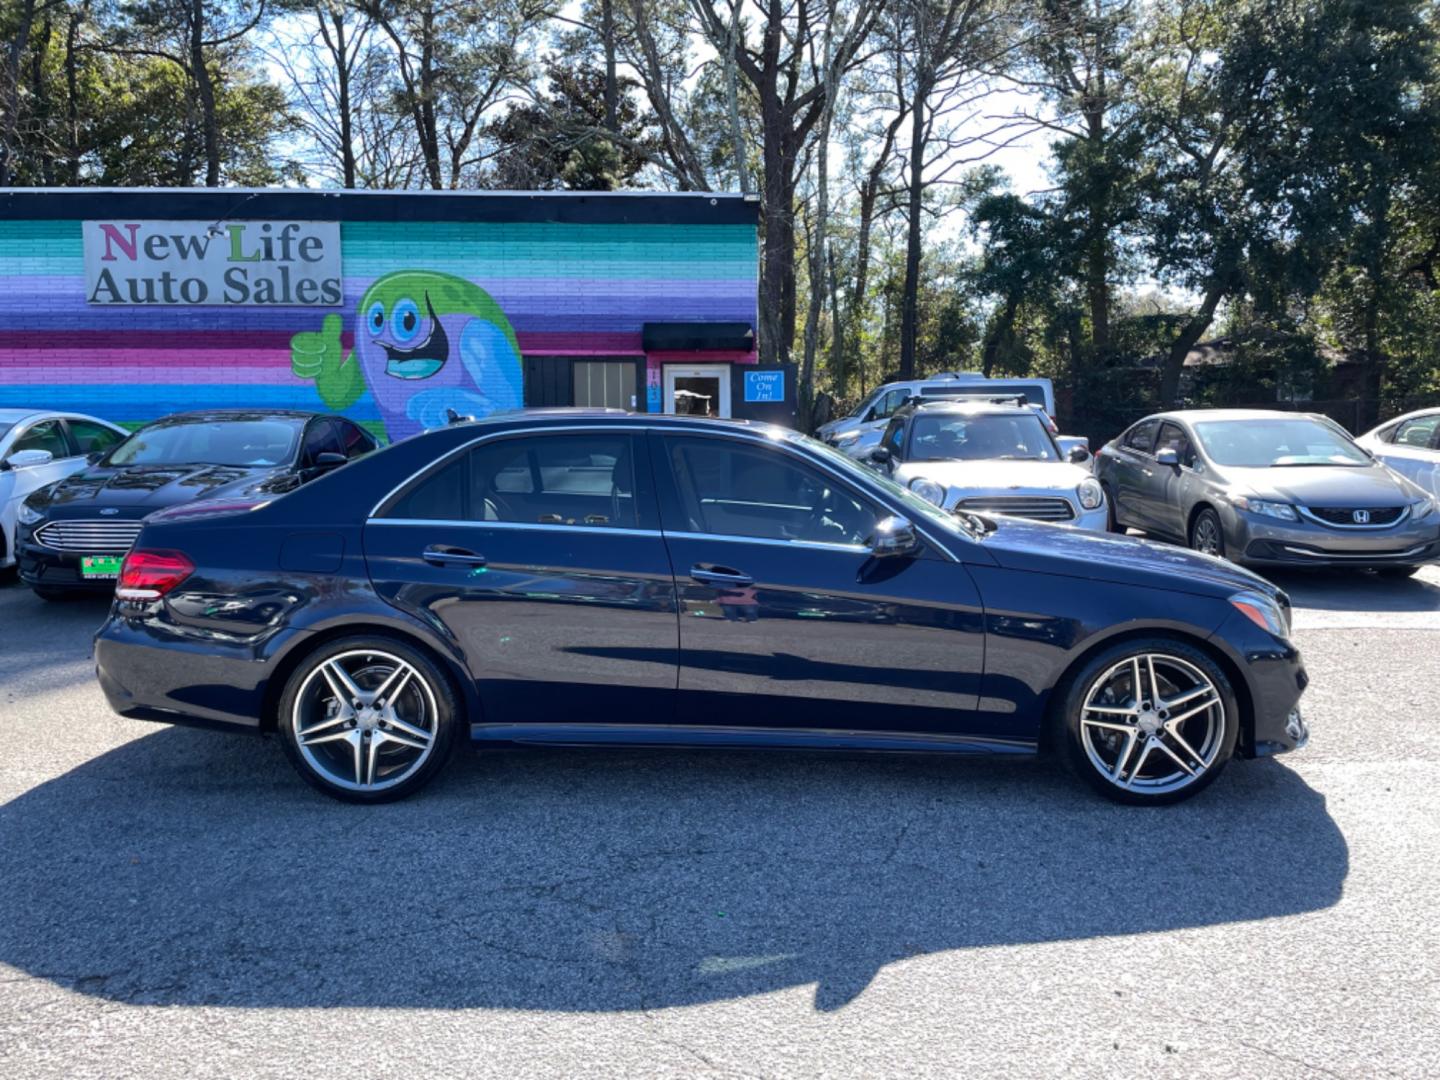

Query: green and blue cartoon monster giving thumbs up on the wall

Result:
[289,271,523,442]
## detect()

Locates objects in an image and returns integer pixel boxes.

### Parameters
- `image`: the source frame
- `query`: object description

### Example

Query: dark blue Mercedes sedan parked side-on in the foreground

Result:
[95,410,1308,804]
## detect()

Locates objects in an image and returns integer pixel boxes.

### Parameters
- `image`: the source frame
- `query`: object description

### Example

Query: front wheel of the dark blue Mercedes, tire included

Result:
[1058,638,1240,805]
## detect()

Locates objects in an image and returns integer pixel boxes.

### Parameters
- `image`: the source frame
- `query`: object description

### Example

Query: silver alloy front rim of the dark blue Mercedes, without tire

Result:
[1080,652,1225,795]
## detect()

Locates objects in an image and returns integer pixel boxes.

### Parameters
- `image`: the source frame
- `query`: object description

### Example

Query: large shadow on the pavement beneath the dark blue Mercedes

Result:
[0,729,1349,1011]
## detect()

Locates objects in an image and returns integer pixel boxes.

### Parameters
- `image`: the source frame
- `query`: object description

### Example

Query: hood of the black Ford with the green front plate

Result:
[26,465,298,517]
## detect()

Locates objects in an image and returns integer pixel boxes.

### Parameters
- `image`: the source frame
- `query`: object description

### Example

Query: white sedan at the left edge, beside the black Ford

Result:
[0,409,128,567]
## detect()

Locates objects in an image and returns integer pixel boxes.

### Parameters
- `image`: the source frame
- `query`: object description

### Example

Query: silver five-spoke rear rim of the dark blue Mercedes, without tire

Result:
[289,649,439,792]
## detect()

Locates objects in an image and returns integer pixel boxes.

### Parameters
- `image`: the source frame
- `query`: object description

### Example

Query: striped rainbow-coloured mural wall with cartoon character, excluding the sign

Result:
[0,192,757,438]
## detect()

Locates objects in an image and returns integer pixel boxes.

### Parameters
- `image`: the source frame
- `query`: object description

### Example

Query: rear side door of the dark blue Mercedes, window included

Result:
[364,428,678,730]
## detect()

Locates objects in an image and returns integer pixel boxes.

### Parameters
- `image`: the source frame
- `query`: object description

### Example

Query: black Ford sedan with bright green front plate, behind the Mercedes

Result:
[16,409,376,599]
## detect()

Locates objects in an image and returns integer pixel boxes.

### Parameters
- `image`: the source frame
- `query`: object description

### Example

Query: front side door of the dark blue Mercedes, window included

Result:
[651,433,1004,736]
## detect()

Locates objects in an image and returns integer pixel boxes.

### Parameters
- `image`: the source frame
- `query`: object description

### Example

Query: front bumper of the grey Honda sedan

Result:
[1225,507,1440,569]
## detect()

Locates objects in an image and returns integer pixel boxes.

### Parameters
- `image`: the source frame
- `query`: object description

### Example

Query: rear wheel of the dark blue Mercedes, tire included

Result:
[275,635,461,804]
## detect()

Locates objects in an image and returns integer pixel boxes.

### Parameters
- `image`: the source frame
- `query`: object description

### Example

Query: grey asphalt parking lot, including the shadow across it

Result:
[0,567,1440,1079]
